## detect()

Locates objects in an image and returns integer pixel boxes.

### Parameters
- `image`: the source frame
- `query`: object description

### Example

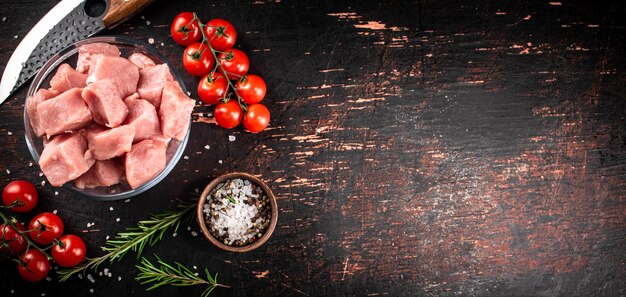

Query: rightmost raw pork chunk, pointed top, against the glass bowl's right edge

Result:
[159,81,196,140]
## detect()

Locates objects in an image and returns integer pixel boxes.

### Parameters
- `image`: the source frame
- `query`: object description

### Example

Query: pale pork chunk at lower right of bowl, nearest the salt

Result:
[125,139,167,189]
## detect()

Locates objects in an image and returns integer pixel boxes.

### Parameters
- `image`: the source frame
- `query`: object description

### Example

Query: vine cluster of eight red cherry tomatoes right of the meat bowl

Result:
[170,12,270,133]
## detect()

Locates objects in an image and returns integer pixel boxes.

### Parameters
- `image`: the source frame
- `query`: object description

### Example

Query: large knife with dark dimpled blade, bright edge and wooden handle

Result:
[0,0,154,104]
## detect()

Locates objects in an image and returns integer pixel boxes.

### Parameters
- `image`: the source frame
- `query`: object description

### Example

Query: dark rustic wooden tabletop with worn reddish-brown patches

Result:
[0,0,626,296]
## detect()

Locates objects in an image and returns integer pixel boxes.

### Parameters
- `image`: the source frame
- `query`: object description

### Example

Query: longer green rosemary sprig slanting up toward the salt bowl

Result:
[57,202,196,282]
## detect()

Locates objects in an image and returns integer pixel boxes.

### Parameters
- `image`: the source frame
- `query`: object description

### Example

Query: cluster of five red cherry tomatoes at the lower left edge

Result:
[0,180,87,282]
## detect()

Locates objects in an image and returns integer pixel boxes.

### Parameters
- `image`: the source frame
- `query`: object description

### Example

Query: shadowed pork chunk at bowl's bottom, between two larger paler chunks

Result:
[74,160,124,189]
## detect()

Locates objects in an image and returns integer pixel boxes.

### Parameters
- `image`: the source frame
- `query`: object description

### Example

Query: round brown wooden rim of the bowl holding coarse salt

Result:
[196,172,278,253]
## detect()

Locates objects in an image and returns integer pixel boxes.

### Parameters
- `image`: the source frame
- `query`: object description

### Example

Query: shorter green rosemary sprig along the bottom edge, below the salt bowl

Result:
[135,255,230,297]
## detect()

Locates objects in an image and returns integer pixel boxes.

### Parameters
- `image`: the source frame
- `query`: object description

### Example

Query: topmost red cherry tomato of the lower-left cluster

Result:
[2,180,39,213]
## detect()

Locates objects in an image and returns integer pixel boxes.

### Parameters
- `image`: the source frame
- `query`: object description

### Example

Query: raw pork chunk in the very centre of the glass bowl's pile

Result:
[81,79,128,128]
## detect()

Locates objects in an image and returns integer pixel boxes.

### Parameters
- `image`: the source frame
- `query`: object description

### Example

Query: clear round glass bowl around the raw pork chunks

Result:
[24,36,191,200]
